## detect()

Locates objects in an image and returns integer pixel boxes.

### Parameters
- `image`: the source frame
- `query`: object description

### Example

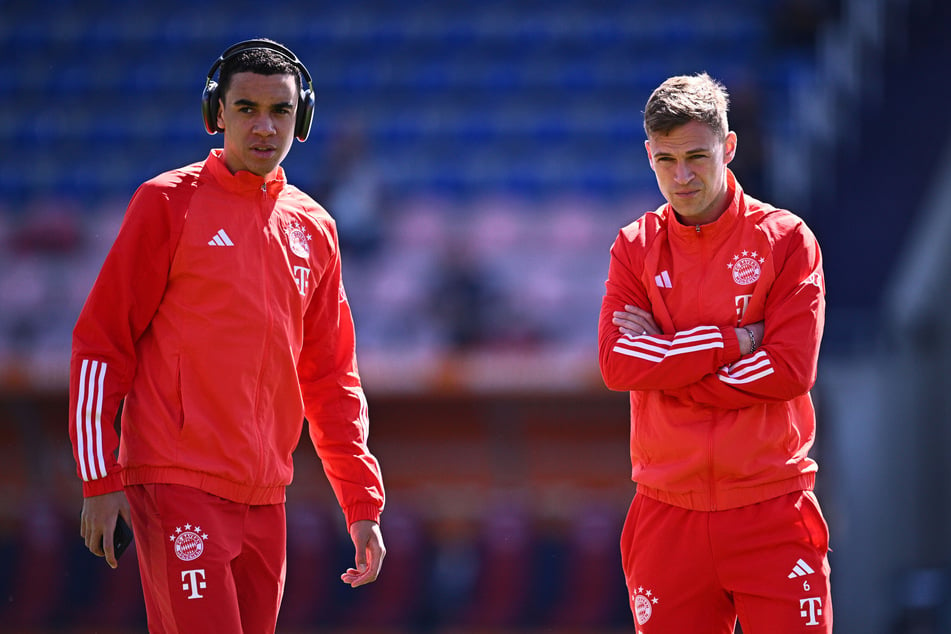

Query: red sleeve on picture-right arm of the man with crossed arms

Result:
[670,221,825,409]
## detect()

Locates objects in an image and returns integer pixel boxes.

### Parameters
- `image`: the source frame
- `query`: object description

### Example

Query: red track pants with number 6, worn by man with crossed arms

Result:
[621,492,832,634]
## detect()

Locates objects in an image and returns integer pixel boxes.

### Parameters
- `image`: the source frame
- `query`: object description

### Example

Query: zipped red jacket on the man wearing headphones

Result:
[69,150,384,525]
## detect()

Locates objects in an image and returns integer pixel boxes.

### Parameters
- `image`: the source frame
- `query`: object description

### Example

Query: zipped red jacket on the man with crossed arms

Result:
[599,171,825,511]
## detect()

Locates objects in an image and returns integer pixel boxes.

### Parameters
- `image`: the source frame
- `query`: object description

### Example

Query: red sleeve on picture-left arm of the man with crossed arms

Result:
[598,225,740,391]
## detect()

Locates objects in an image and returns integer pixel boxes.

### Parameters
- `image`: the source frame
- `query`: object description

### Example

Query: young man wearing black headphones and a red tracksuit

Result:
[69,40,386,634]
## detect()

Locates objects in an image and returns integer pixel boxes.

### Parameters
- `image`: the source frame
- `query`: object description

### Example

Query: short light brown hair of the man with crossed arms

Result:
[644,73,730,141]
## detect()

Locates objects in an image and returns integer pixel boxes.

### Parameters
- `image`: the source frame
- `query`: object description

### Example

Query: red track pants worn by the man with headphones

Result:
[126,484,287,634]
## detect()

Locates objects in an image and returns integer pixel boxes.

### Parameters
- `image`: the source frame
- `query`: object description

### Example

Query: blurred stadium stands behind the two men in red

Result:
[0,0,951,634]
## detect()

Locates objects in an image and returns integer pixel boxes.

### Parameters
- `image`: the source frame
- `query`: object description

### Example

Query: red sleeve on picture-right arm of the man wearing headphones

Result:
[298,224,385,526]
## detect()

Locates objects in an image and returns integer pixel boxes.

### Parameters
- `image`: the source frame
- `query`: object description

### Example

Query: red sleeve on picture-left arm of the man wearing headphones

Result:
[69,183,181,497]
